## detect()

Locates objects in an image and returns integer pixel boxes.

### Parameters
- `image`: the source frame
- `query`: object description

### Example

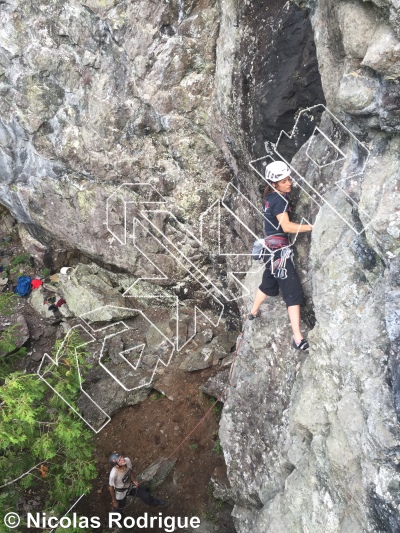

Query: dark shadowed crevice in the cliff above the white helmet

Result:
[236,0,325,157]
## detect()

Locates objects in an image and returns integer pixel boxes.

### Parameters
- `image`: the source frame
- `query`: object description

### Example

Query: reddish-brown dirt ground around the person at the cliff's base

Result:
[77,360,235,533]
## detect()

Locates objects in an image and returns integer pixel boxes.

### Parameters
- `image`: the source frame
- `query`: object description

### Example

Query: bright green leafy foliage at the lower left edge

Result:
[0,328,96,522]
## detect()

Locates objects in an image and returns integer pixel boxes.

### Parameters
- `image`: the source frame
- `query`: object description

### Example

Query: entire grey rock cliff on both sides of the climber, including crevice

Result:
[0,0,400,533]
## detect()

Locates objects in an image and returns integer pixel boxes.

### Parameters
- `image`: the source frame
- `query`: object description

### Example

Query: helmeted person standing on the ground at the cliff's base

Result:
[108,452,168,512]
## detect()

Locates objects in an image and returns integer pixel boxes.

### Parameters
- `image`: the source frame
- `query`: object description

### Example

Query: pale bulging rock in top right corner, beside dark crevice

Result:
[310,0,400,135]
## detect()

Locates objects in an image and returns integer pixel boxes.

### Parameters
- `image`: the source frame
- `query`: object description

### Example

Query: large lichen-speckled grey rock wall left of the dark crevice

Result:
[0,1,227,270]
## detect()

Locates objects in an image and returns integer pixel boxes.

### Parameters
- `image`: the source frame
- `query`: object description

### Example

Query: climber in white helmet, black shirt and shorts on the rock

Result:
[248,161,313,350]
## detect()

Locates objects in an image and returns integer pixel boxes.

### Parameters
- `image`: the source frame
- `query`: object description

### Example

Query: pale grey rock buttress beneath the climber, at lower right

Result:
[220,172,400,533]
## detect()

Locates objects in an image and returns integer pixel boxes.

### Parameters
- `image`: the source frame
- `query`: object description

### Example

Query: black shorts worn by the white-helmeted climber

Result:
[259,259,304,307]
